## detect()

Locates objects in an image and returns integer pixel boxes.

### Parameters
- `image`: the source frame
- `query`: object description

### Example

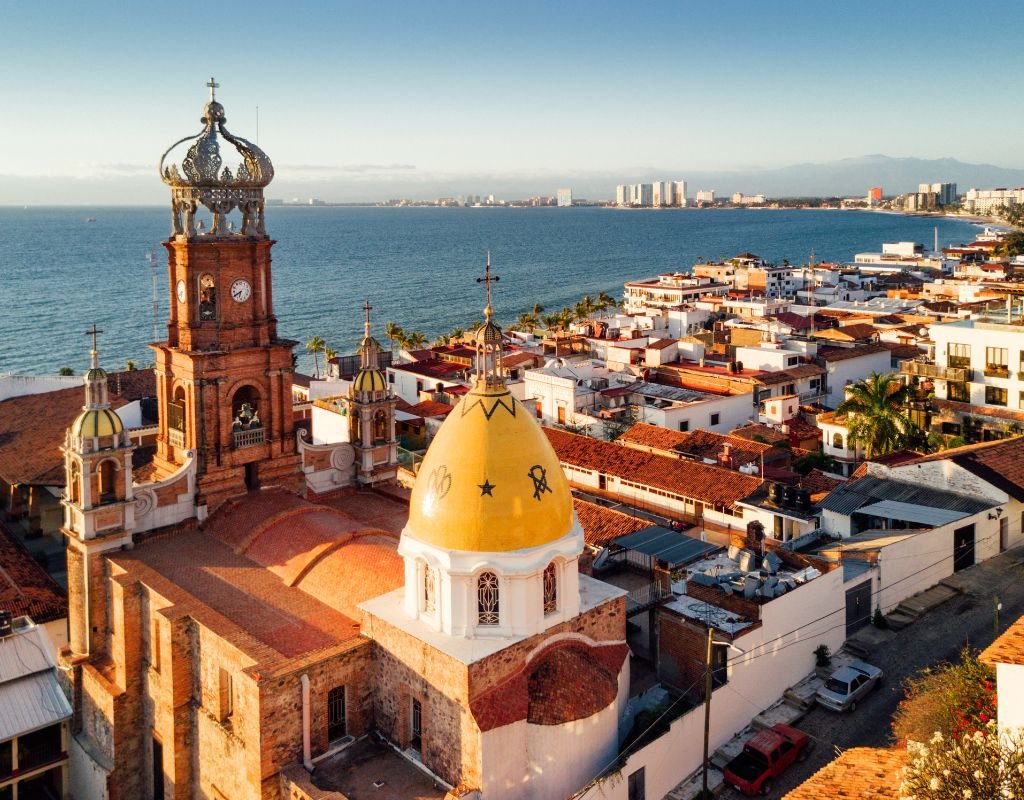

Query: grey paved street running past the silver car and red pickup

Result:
[721,548,1024,800]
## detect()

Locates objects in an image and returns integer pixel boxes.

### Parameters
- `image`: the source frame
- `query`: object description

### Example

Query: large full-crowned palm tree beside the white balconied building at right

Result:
[836,372,914,458]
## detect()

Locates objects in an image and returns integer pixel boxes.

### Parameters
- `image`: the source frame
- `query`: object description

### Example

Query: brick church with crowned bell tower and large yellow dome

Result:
[62,80,629,800]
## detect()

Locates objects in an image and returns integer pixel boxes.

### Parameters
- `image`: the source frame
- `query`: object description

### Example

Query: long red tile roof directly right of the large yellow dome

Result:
[544,428,762,506]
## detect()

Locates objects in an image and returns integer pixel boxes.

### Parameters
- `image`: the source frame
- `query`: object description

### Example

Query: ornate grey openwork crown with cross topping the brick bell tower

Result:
[160,78,273,239]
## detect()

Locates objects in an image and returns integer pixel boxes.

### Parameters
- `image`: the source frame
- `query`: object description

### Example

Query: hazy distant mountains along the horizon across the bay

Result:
[0,155,1024,205]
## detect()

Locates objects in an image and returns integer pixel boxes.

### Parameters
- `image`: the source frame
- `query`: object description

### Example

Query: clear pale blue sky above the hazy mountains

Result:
[0,0,1024,203]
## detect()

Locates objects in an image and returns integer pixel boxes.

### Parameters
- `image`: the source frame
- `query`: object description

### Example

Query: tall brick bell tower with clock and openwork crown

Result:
[151,78,304,508]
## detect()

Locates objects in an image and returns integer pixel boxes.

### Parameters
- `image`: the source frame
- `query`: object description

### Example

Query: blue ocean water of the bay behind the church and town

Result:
[0,207,977,374]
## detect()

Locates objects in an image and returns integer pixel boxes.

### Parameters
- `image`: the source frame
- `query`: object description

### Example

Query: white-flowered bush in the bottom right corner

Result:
[899,720,1024,800]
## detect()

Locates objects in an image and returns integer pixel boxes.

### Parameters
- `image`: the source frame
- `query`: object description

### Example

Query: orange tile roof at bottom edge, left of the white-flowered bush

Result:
[784,747,906,800]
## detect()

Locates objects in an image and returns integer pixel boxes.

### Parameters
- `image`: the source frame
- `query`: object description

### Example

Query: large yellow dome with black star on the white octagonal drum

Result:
[407,380,572,552]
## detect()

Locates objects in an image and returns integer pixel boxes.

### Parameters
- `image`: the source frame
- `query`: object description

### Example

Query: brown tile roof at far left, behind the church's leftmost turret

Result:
[0,370,157,487]
